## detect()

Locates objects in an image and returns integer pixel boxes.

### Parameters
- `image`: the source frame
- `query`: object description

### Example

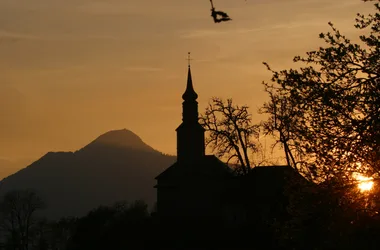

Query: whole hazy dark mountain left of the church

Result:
[0,129,176,219]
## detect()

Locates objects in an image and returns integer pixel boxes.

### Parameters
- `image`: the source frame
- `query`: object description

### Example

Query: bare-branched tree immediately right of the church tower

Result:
[200,97,261,174]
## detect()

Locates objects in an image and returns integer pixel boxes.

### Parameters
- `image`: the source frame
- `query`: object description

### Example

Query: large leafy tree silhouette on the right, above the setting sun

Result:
[262,0,380,181]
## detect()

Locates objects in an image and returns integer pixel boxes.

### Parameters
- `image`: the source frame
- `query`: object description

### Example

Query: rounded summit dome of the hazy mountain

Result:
[85,129,154,151]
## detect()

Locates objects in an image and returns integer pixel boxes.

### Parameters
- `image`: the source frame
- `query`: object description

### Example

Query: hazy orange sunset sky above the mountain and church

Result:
[0,0,372,177]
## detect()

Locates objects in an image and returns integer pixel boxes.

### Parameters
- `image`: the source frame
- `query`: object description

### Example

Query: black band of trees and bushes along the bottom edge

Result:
[1,186,380,250]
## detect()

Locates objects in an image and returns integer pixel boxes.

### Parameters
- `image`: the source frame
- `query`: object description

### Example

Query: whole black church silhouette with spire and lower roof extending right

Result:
[155,62,309,242]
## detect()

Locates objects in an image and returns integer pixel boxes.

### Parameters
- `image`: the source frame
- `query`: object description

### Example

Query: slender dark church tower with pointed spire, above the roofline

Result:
[176,61,205,162]
